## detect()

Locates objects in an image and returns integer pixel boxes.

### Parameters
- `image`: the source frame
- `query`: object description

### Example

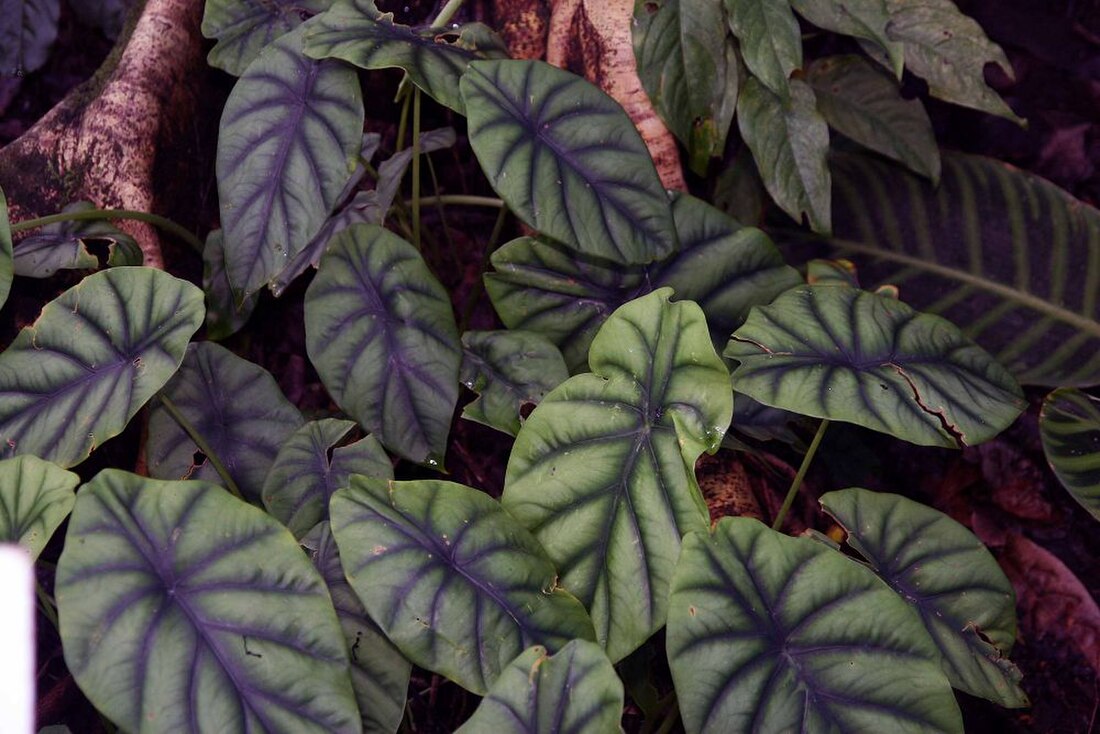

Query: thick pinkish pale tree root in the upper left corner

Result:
[0,0,205,267]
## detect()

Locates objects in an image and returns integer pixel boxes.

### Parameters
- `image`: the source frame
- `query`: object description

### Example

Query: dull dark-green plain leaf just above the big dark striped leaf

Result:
[805,56,941,184]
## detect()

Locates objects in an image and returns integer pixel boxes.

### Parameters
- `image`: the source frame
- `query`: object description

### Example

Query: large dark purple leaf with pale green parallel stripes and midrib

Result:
[773,153,1100,387]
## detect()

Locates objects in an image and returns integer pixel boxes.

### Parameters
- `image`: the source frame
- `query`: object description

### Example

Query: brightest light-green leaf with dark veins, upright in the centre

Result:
[503,288,733,660]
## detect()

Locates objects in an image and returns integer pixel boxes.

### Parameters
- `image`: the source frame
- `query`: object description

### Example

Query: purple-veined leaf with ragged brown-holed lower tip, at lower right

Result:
[821,489,1027,706]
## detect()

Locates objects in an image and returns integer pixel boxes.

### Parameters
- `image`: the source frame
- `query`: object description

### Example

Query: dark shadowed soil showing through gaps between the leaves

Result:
[0,0,1100,734]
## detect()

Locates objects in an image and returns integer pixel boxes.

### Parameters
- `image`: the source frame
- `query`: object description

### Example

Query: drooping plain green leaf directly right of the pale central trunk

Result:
[633,0,740,175]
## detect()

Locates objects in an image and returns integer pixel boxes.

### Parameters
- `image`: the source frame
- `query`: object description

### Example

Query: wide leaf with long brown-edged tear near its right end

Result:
[725,285,1026,448]
